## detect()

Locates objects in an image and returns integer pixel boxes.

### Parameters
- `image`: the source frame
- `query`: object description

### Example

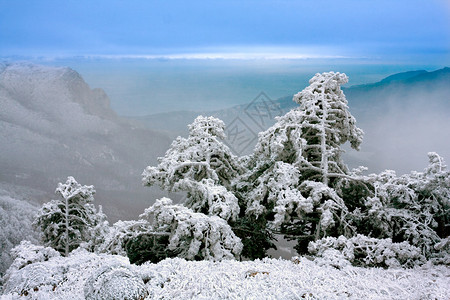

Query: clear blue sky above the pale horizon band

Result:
[0,0,450,63]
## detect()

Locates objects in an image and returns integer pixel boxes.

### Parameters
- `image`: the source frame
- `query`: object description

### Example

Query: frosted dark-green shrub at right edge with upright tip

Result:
[366,152,450,257]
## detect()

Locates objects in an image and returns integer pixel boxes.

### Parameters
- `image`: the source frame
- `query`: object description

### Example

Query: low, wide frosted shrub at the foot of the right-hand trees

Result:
[308,234,425,267]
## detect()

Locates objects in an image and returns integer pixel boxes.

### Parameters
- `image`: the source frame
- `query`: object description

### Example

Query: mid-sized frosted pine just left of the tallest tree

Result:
[143,116,272,258]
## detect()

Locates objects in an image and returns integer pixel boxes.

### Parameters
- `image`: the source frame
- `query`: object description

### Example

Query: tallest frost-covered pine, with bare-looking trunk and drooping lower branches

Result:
[238,72,363,250]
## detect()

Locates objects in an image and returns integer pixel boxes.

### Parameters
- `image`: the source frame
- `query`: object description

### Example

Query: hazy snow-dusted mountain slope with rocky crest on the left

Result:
[0,63,171,220]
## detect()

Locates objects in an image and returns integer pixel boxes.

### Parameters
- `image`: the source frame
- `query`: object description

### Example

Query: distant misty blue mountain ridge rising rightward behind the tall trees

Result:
[131,68,450,173]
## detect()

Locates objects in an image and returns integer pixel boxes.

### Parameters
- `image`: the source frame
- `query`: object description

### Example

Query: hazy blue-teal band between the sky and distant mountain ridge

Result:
[5,57,445,116]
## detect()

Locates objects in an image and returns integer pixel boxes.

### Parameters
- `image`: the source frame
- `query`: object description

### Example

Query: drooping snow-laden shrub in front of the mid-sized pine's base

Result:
[140,198,242,260]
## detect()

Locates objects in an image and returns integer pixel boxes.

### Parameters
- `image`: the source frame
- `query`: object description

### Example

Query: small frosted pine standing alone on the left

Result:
[33,177,106,256]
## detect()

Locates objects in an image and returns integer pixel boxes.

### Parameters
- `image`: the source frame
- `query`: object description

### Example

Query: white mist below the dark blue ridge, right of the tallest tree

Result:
[346,73,450,174]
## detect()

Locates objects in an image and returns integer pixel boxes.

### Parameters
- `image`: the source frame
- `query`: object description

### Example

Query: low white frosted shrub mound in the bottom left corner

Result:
[2,242,146,299]
